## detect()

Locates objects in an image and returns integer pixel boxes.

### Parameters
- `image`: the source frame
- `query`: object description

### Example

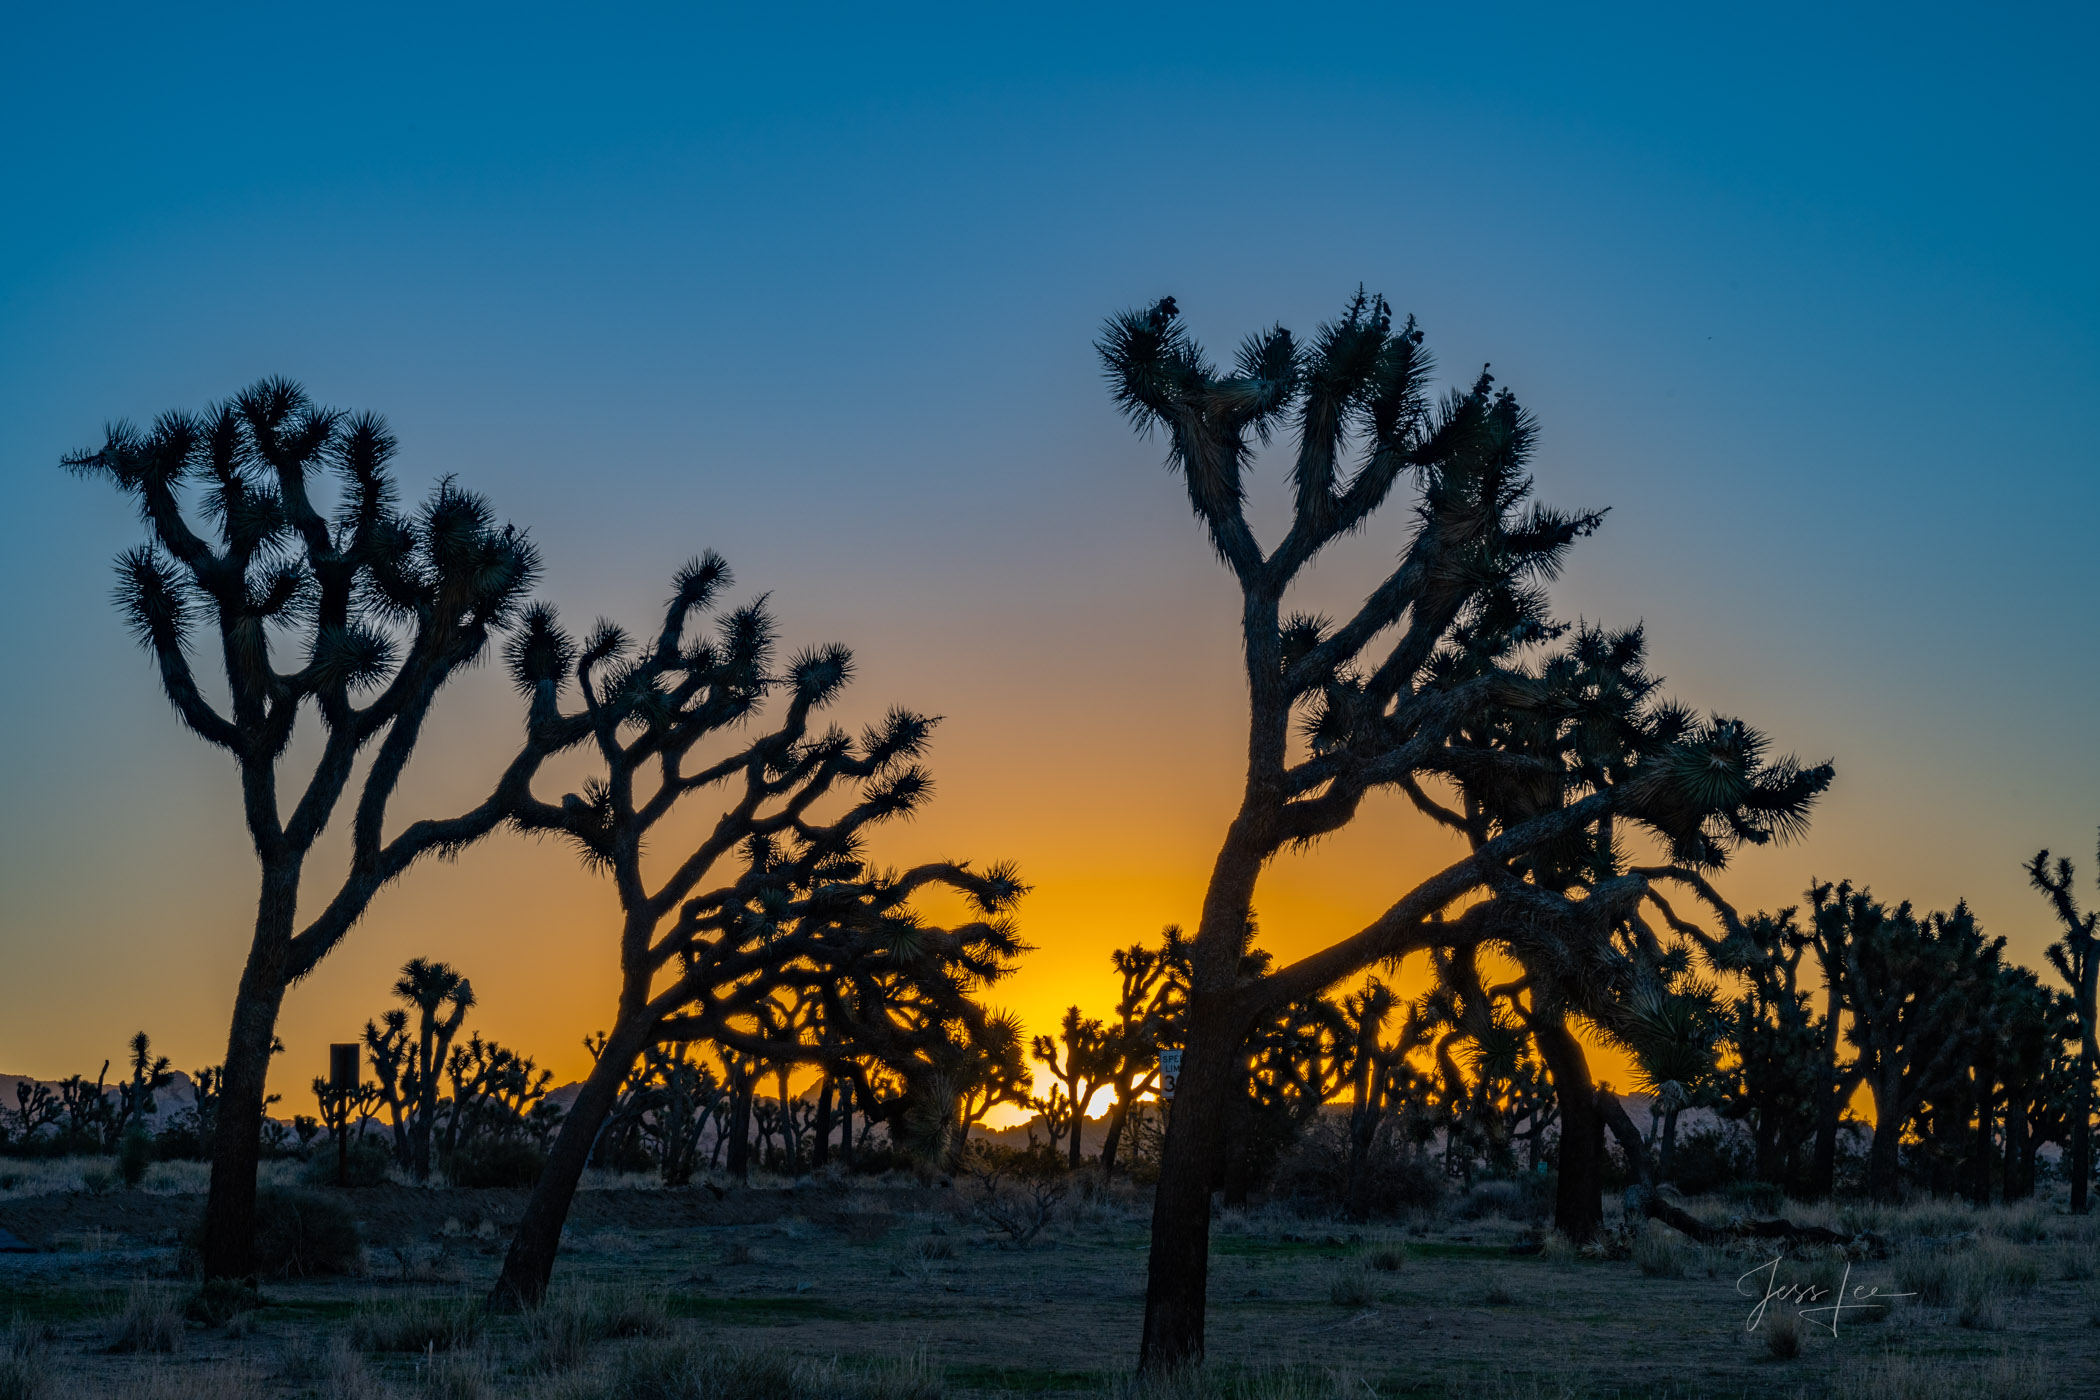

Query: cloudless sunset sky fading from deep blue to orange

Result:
[0,6,2100,1073]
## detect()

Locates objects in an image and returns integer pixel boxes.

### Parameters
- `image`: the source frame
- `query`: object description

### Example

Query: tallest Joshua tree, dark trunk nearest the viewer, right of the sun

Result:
[1098,294,1827,1371]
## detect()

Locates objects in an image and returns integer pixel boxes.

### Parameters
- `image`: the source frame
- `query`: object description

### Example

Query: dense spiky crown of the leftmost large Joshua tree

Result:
[65,380,540,754]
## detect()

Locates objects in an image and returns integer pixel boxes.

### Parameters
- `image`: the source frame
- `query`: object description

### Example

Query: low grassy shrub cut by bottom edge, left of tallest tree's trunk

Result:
[604,1339,943,1400]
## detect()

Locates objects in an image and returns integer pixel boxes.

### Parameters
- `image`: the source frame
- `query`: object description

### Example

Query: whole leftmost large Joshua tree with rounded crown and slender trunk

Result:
[67,380,573,1278]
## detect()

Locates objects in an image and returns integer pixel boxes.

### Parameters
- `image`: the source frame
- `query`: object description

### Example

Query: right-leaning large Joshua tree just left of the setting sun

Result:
[494,554,1021,1306]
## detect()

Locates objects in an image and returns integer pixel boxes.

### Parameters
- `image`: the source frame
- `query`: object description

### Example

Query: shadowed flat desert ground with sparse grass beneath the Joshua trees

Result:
[0,1163,2100,1400]
